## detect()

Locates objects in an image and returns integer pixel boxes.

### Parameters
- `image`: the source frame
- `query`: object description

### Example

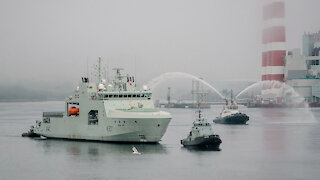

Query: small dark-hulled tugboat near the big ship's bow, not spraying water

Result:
[181,108,222,149]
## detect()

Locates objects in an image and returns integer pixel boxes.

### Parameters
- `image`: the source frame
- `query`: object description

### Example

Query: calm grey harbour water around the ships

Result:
[0,102,320,180]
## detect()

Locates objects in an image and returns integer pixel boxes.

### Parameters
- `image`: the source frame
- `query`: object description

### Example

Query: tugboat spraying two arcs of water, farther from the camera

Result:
[213,90,249,124]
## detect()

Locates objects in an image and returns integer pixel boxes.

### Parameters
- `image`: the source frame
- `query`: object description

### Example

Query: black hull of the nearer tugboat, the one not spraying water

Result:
[181,135,222,147]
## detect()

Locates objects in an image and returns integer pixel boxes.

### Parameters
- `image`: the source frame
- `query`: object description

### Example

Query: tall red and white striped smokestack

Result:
[261,0,286,82]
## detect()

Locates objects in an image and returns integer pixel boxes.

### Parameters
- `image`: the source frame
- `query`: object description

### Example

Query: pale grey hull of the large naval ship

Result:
[35,115,171,143]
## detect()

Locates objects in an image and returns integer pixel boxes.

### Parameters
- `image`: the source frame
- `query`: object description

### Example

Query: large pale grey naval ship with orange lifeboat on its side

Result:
[22,68,171,143]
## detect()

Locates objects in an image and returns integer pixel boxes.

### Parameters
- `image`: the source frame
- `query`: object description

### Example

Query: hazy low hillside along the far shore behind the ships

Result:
[0,80,254,102]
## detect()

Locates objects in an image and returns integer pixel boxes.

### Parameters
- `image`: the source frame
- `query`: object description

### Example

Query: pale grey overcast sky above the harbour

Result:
[0,0,320,87]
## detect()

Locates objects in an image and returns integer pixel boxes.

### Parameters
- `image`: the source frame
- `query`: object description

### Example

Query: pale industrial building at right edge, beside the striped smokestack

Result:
[284,31,320,106]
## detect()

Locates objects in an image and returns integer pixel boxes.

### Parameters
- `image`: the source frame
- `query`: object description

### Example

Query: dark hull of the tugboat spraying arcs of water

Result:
[213,113,249,124]
